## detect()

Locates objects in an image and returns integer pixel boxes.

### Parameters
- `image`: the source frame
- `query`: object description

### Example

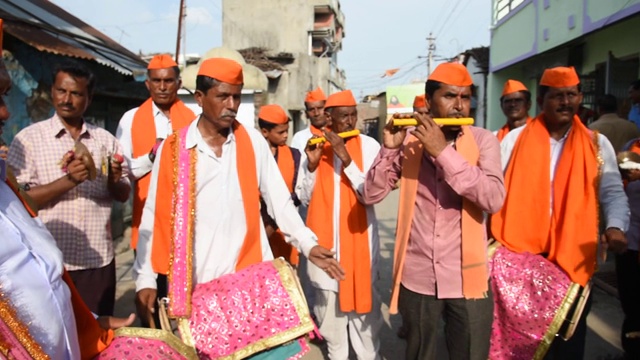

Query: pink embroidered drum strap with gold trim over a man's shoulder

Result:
[167,127,191,317]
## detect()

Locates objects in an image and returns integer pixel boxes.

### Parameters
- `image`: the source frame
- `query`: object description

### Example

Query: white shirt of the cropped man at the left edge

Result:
[0,181,80,360]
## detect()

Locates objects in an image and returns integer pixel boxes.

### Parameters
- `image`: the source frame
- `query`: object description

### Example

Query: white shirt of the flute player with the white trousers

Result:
[296,135,380,292]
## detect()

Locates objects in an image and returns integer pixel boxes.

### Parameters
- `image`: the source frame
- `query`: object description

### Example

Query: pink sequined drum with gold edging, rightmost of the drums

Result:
[489,242,591,360]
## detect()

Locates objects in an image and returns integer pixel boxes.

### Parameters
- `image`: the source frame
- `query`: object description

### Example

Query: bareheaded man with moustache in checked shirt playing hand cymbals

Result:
[7,63,131,315]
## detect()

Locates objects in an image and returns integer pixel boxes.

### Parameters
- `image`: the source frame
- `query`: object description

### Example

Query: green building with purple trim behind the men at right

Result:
[487,0,640,129]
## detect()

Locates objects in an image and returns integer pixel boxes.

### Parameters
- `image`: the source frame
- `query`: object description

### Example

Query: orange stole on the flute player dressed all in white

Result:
[307,136,372,314]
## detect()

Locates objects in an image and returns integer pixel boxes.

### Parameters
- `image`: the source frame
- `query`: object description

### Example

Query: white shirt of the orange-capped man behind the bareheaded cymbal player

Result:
[116,103,178,180]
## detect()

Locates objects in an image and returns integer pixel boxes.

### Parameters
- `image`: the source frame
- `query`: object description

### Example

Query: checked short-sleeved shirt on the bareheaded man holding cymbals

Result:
[7,115,129,270]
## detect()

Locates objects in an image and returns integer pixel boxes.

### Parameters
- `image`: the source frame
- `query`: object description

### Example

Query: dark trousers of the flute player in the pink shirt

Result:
[398,285,493,360]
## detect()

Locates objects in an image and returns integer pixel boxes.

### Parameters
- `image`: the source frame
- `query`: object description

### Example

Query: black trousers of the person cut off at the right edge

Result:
[616,250,640,359]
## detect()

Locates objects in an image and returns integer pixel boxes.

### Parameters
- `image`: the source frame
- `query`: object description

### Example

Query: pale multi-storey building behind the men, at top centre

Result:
[222,0,345,130]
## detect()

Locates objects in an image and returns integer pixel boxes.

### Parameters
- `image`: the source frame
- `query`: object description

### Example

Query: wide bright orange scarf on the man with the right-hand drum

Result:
[491,114,600,286]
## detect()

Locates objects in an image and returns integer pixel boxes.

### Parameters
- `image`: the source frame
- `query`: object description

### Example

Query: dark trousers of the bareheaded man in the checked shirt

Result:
[69,259,116,316]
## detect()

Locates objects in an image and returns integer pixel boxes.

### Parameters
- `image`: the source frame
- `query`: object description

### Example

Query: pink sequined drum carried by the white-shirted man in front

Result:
[161,258,315,359]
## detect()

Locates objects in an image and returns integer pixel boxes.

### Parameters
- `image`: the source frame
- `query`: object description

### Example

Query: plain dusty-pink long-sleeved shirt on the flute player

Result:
[363,127,505,299]
